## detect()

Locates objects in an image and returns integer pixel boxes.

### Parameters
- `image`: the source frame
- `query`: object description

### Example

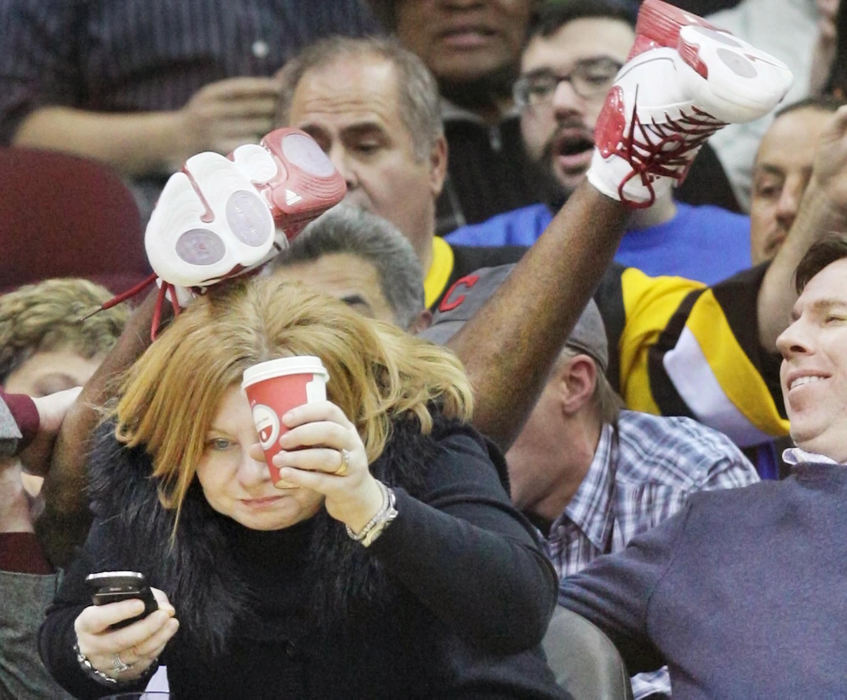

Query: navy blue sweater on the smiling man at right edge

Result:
[560,464,847,700]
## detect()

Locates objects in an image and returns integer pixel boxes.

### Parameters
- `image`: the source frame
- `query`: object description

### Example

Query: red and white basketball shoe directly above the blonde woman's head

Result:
[144,128,346,289]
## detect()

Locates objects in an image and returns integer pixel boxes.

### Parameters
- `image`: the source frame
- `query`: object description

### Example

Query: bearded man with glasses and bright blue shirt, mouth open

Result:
[446,0,751,284]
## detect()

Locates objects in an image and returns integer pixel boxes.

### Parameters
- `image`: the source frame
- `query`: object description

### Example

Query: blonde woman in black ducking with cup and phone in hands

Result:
[40,277,562,699]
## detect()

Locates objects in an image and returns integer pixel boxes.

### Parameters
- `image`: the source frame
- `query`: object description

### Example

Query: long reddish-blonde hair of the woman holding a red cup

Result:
[115,276,472,519]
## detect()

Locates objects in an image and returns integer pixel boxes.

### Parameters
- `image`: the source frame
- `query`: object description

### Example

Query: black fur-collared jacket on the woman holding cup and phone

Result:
[40,412,562,699]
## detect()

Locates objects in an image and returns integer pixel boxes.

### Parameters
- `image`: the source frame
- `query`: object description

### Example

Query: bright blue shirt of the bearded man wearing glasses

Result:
[445,202,752,284]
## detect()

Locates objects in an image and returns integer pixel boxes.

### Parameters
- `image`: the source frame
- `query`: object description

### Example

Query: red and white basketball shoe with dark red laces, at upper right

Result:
[588,0,792,207]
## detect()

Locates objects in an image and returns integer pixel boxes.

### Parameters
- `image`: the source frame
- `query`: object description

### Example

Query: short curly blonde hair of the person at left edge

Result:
[0,277,129,382]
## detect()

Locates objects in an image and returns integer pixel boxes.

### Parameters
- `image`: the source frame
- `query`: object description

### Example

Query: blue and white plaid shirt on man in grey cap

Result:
[546,411,759,698]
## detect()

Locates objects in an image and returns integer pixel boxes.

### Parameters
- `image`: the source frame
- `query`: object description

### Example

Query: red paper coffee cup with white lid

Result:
[241,355,329,488]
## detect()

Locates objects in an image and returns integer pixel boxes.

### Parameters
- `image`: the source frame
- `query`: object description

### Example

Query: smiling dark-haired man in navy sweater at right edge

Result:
[559,234,847,699]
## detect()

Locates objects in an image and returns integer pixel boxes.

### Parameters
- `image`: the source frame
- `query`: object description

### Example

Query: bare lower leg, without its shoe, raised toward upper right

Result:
[448,181,628,451]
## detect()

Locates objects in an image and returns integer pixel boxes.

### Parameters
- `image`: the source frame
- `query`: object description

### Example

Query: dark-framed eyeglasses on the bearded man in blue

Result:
[513,56,623,109]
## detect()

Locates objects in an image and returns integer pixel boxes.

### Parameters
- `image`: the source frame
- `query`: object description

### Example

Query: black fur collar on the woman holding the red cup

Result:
[89,416,494,655]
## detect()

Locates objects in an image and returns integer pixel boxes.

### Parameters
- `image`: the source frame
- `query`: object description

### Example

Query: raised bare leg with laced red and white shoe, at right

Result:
[449,2,792,448]
